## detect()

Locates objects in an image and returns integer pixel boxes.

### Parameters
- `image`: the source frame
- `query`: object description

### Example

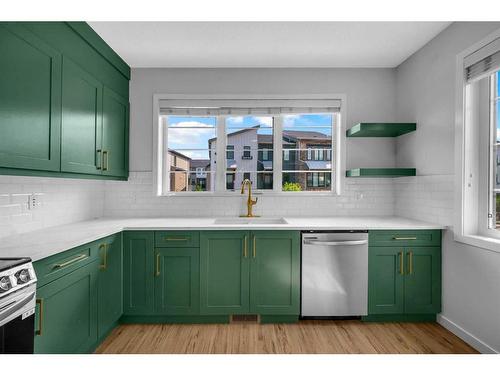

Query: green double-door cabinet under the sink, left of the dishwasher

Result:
[200,231,300,316]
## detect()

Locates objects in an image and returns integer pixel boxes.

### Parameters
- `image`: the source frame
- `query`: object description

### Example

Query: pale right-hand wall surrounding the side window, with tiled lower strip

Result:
[395,22,500,352]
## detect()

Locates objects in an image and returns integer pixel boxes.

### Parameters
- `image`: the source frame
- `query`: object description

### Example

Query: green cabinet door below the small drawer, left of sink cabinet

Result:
[155,247,200,315]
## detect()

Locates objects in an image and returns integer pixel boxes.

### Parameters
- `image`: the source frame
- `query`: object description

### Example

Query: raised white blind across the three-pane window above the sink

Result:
[160,99,341,116]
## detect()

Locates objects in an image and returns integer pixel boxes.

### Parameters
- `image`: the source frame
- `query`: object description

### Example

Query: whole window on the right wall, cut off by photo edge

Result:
[454,30,500,252]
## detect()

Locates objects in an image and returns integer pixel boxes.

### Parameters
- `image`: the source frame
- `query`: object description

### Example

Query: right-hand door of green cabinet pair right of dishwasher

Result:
[404,247,441,314]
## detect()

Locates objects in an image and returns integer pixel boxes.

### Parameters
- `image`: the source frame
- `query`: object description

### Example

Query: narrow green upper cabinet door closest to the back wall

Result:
[102,87,129,177]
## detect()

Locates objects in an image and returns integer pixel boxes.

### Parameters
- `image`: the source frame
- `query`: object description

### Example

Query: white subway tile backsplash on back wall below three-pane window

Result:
[104,172,394,217]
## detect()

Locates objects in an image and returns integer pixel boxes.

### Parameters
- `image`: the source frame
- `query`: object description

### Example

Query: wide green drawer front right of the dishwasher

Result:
[368,230,441,247]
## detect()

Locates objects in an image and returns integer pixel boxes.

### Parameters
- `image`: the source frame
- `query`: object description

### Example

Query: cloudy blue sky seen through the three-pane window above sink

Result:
[168,114,332,159]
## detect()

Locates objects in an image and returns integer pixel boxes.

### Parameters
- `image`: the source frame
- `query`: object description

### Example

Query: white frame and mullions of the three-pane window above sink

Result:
[153,94,347,197]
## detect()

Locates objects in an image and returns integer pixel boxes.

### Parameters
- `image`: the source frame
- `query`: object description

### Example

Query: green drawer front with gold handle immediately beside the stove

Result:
[33,241,102,287]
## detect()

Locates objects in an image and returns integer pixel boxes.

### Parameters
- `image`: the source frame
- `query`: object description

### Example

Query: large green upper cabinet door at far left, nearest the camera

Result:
[0,22,61,171]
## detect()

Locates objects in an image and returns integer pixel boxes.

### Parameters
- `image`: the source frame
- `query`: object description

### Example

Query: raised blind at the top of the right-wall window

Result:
[464,38,500,82]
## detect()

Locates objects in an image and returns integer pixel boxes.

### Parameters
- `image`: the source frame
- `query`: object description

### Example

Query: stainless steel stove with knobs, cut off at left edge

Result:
[0,258,36,354]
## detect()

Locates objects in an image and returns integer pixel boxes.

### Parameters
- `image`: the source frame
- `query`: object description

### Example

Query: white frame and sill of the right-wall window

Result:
[453,29,500,252]
